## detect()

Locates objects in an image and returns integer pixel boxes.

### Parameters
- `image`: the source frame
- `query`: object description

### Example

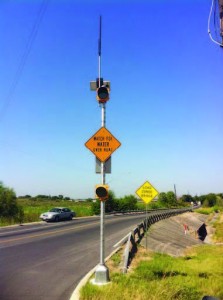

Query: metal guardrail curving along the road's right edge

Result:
[114,207,193,273]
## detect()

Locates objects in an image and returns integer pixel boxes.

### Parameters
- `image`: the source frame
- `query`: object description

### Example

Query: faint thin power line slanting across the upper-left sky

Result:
[0,0,49,121]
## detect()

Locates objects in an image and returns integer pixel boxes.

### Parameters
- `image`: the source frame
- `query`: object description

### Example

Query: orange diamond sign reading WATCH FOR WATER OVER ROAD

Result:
[85,127,121,162]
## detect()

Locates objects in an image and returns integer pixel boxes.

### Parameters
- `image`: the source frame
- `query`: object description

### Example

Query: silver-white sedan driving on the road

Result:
[40,207,76,222]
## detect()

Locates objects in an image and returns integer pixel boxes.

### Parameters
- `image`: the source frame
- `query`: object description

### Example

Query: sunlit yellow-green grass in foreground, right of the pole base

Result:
[81,215,223,300]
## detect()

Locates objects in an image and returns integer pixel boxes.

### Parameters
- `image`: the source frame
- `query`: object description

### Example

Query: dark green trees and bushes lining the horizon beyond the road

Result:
[0,182,223,222]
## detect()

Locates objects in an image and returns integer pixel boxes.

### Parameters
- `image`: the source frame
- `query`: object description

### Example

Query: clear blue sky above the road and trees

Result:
[0,0,223,198]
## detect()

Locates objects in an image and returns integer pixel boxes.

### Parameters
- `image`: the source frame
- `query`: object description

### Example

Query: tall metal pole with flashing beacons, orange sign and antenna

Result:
[85,16,121,285]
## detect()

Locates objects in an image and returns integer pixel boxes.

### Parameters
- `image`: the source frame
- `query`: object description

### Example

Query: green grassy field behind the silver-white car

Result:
[0,199,92,226]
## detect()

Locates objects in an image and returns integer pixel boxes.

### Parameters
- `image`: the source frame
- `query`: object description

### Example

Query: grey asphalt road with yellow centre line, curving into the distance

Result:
[0,215,145,300]
